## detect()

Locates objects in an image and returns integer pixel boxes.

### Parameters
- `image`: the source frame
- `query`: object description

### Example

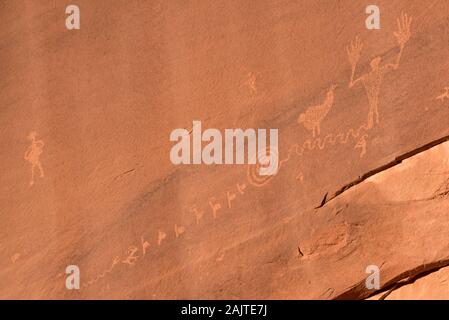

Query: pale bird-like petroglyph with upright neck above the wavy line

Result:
[298,84,337,138]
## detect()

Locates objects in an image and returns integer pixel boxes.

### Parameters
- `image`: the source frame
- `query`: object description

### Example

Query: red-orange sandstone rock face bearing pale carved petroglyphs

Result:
[0,0,449,299]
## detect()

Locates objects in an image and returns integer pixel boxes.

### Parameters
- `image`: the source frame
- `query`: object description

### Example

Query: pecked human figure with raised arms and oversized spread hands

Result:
[346,14,412,129]
